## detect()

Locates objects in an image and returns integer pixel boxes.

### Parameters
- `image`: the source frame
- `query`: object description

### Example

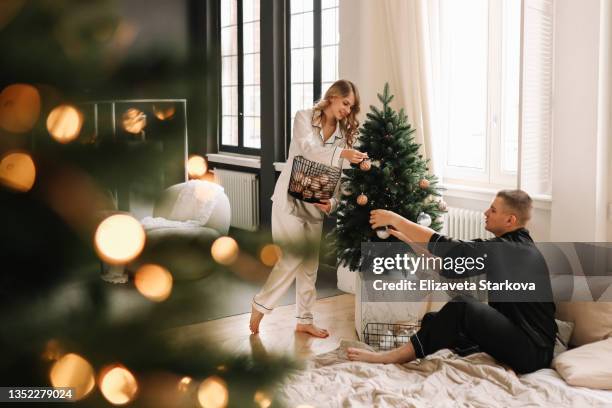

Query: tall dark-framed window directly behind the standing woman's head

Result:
[287,0,339,141]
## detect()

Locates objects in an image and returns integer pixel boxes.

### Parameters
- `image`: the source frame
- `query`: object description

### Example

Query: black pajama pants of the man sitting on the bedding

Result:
[410,296,553,374]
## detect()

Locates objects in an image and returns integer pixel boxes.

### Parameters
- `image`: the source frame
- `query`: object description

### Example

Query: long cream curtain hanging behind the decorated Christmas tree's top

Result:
[340,0,443,172]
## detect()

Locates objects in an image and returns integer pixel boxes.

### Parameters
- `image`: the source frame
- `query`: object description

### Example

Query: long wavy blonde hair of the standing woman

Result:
[312,79,360,147]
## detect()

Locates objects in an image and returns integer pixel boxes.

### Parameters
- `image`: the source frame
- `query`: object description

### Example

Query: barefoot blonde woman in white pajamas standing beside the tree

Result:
[250,80,368,337]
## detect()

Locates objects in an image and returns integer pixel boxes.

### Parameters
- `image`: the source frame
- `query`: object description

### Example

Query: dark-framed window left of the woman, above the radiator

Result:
[220,0,261,154]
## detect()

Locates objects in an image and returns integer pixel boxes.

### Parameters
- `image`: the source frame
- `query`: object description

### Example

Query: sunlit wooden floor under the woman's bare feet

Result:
[172,294,357,359]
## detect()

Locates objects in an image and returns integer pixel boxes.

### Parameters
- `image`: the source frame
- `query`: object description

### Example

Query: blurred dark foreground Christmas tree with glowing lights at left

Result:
[0,0,294,407]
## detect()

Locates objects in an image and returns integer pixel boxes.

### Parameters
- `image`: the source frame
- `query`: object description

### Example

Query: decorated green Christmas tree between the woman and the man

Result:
[332,84,446,270]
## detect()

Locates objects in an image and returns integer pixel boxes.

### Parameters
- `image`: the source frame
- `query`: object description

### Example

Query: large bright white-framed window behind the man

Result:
[440,0,521,187]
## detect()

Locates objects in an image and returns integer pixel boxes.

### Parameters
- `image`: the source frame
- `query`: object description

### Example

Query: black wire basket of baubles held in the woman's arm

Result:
[288,156,341,203]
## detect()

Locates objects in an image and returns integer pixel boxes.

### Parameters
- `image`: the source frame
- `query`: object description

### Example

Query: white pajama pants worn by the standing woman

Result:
[253,203,323,324]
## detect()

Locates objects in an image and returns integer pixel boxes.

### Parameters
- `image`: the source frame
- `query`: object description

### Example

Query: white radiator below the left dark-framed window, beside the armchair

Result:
[214,168,259,231]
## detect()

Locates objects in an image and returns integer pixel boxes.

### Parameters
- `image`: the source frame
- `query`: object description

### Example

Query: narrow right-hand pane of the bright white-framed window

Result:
[501,1,521,173]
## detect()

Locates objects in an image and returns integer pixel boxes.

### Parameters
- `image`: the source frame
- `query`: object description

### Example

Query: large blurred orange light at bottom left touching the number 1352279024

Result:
[49,353,96,399]
